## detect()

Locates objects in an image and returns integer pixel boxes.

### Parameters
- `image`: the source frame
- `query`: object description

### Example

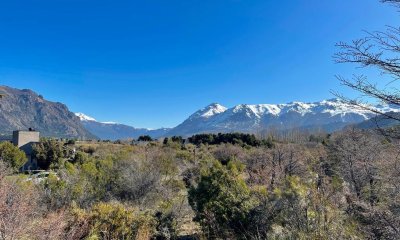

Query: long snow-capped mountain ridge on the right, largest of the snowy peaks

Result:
[168,99,399,136]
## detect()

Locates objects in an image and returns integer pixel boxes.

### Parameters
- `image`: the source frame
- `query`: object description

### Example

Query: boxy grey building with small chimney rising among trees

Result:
[12,129,40,171]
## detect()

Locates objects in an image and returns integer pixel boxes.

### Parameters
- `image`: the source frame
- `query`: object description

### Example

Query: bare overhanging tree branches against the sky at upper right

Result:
[334,0,400,135]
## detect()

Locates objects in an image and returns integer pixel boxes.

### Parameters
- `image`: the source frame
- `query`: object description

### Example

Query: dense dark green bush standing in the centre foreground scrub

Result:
[189,161,254,237]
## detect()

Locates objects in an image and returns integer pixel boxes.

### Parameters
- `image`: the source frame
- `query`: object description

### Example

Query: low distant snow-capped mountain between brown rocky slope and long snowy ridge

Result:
[75,113,170,140]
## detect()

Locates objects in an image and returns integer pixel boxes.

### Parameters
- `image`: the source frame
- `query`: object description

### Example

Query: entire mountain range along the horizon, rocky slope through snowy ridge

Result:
[0,86,400,140]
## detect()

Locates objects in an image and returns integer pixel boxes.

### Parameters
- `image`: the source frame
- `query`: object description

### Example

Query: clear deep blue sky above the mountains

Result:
[0,0,399,128]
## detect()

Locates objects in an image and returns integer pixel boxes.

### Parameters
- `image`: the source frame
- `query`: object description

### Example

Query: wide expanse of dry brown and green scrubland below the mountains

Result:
[0,129,400,239]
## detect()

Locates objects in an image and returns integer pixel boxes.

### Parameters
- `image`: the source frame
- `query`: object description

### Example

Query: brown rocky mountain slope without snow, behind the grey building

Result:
[0,86,96,139]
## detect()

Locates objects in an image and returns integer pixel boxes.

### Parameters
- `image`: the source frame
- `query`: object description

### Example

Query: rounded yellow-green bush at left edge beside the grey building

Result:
[0,142,27,171]
